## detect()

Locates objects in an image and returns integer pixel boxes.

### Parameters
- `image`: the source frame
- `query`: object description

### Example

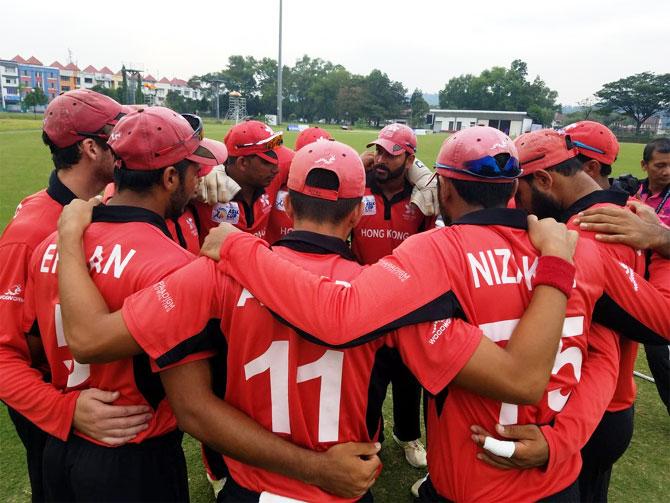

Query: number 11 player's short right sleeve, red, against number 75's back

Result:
[389,318,483,395]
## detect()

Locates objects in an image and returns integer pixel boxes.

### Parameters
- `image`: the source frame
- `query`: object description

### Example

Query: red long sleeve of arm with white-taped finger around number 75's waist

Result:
[541,324,619,471]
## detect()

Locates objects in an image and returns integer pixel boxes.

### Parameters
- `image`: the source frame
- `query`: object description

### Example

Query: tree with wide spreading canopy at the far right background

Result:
[596,72,670,134]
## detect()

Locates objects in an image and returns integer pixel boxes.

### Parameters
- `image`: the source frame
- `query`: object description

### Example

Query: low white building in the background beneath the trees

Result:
[426,108,532,138]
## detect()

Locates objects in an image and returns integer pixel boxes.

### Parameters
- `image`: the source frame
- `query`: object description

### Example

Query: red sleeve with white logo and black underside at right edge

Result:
[594,253,670,344]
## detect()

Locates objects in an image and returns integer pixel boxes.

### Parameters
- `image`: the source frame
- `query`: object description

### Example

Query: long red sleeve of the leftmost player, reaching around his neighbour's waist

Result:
[0,244,79,440]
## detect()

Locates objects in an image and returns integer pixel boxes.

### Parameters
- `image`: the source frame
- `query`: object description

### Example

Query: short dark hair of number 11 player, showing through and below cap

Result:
[289,168,363,224]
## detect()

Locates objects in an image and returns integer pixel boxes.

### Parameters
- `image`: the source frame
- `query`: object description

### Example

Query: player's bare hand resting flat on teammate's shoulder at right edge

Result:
[575,201,670,251]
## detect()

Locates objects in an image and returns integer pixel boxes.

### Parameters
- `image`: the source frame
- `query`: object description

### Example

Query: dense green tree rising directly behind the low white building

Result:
[439,59,560,124]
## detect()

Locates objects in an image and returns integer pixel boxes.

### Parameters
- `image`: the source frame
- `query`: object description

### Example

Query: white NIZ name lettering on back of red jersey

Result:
[467,248,538,290]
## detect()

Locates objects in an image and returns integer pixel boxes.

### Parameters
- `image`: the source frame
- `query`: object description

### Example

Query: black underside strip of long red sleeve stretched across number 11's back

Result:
[271,290,465,349]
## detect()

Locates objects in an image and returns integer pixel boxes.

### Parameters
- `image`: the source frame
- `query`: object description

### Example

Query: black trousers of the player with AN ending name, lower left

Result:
[44,431,189,502]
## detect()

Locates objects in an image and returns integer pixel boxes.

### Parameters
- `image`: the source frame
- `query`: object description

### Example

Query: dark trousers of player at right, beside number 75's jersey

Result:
[578,407,635,502]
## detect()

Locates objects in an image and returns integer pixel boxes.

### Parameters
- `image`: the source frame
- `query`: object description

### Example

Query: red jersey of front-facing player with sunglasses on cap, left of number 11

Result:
[195,163,289,239]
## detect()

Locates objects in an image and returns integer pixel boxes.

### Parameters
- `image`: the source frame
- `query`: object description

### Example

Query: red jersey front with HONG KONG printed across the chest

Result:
[351,173,435,264]
